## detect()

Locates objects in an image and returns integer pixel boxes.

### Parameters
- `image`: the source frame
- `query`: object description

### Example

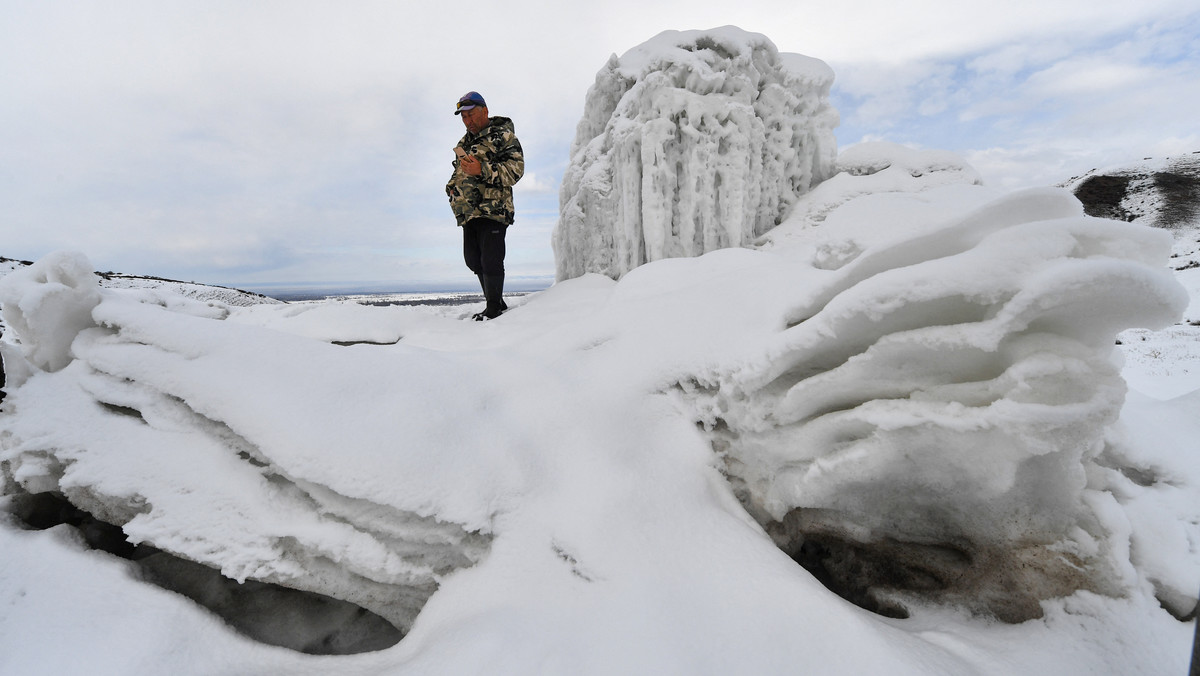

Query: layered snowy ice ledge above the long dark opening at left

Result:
[0,252,490,630]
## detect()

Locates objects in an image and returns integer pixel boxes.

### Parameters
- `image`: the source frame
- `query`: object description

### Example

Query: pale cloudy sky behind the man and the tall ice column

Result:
[0,0,1200,291]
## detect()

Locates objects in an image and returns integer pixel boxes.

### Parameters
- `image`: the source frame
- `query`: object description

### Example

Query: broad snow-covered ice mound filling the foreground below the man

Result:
[0,183,1200,675]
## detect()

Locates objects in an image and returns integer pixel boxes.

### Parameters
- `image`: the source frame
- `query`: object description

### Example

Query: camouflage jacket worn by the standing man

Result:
[446,116,524,226]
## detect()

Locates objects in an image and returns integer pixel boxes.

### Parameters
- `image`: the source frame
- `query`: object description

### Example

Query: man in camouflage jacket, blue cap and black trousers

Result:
[446,91,524,322]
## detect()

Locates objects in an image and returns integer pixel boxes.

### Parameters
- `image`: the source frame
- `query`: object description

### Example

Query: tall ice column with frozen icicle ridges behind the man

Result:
[553,26,838,280]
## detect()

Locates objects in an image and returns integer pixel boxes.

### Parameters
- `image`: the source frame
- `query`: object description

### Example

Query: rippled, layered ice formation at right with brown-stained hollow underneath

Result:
[680,190,1200,621]
